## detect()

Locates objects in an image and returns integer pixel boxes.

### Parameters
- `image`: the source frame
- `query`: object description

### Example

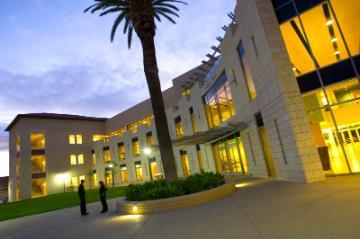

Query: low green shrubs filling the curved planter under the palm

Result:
[126,173,225,201]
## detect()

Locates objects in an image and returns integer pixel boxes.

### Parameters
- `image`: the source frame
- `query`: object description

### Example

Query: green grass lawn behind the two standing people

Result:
[0,187,126,221]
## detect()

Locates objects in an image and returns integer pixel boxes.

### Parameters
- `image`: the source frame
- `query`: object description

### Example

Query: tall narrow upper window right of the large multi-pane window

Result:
[238,41,256,100]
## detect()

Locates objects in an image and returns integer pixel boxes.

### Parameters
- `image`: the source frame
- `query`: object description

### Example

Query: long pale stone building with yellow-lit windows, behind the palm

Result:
[7,0,360,201]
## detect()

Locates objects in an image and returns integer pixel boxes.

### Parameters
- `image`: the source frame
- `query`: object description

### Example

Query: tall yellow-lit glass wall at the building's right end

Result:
[280,0,360,174]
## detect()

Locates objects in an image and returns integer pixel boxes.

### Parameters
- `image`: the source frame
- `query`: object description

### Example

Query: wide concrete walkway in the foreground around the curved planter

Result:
[0,175,360,239]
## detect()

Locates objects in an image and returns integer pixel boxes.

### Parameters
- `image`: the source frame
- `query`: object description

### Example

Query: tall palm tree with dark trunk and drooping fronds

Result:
[84,0,186,181]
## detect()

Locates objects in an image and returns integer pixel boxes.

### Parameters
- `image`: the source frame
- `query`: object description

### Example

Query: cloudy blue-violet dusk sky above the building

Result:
[0,0,236,176]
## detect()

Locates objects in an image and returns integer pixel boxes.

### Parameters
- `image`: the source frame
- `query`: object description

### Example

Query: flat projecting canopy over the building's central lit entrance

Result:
[172,122,246,146]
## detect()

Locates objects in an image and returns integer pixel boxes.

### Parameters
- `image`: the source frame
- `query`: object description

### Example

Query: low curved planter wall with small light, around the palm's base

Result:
[116,183,236,214]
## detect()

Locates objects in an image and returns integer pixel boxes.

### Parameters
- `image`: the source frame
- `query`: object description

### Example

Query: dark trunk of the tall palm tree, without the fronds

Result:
[140,34,177,181]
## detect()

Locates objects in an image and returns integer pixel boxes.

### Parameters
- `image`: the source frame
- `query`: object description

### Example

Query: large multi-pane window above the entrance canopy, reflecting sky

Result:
[204,72,235,128]
